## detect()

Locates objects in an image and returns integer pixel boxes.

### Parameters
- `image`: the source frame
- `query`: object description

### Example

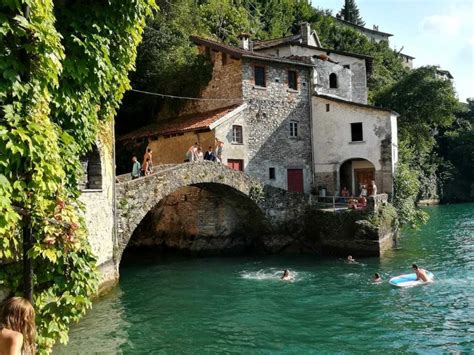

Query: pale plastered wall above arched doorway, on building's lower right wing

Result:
[312,96,397,192]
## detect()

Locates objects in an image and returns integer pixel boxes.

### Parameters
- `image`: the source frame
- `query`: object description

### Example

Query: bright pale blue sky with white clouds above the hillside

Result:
[311,0,474,101]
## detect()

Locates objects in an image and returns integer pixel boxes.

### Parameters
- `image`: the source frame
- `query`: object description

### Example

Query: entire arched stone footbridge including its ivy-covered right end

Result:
[115,161,308,267]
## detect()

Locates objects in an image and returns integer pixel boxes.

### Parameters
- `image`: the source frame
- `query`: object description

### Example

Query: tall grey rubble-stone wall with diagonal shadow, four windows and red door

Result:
[243,60,312,193]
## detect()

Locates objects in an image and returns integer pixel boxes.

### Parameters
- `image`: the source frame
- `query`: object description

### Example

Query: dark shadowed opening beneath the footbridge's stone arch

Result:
[120,183,269,260]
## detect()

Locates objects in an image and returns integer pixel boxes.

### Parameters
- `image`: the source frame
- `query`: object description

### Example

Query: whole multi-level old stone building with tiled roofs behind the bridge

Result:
[121,23,397,194]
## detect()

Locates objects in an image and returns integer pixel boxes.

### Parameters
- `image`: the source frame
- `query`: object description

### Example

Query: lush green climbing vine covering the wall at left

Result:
[0,0,155,352]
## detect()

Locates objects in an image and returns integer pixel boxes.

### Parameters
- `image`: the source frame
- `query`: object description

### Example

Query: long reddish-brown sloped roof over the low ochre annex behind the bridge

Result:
[118,105,240,141]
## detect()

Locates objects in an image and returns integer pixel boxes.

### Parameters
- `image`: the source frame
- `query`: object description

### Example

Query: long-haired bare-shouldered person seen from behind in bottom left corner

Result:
[0,297,36,355]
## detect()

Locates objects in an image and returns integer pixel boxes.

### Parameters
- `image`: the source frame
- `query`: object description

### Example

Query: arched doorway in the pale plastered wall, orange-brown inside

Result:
[339,158,375,196]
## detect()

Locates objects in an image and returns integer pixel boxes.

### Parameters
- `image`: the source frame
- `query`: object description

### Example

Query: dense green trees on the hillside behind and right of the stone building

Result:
[116,0,474,224]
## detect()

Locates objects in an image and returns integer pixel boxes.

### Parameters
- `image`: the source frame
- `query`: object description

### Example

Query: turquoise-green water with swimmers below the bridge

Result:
[55,204,474,354]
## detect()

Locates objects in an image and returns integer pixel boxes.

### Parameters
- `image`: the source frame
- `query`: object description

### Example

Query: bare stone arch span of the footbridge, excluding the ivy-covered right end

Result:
[115,161,265,267]
